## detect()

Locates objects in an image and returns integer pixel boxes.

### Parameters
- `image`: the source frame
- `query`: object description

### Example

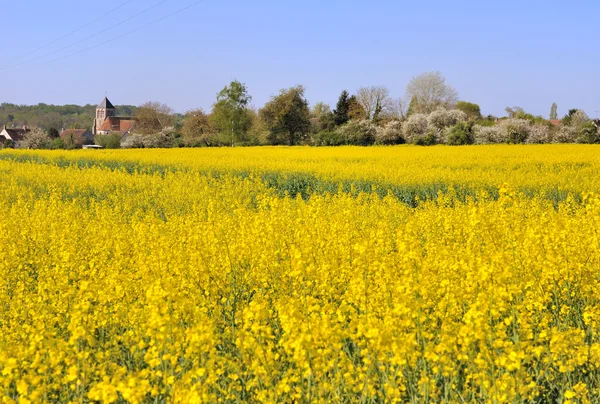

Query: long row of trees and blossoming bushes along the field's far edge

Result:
[0,72,600,148]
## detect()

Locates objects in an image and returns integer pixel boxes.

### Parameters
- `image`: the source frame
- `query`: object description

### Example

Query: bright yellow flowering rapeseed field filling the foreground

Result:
[0,145,600,403]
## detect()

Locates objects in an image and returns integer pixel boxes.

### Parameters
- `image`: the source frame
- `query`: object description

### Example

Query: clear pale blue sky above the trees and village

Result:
[0,0,600,117]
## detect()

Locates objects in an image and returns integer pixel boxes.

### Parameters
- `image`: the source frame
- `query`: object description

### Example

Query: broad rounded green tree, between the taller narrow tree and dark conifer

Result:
[259,86,310,146]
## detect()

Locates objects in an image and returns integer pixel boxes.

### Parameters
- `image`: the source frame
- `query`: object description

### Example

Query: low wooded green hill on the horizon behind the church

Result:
[0,103,137,130]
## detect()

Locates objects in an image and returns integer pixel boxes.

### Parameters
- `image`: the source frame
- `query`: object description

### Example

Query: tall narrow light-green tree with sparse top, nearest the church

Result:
[210,80,252,146]
